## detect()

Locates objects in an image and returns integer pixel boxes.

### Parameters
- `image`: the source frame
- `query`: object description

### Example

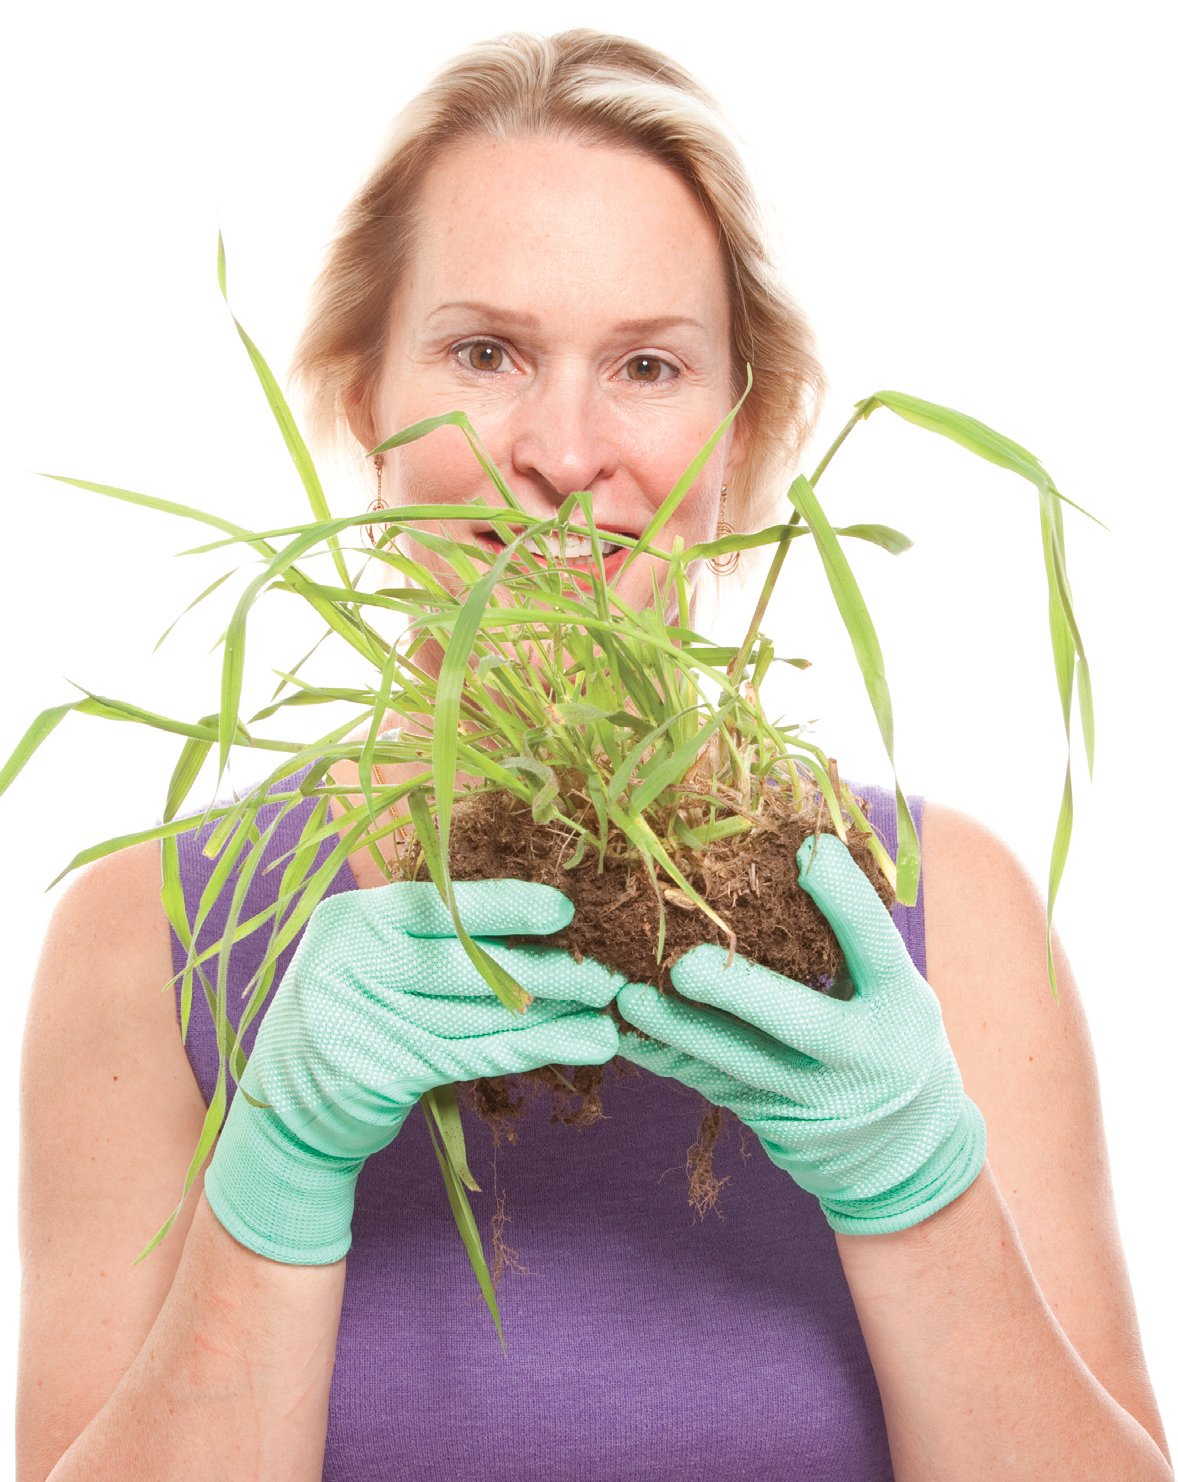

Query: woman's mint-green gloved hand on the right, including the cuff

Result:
[616,834,985,1235]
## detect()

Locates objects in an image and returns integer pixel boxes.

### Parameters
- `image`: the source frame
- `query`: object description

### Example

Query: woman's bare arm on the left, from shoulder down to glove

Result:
[16,843,344,1482]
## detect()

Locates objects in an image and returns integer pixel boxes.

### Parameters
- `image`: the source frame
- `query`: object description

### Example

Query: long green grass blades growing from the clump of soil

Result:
[0,237,1099,1340]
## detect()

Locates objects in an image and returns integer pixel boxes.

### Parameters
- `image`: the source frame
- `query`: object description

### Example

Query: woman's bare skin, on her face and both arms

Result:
[18,141,1172,1482]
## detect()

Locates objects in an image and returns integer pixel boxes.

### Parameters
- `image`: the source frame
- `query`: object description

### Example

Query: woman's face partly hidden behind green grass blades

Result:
[353,138,739,649]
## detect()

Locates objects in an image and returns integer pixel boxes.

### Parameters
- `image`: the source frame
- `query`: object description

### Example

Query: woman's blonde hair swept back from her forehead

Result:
[292,30,825,529]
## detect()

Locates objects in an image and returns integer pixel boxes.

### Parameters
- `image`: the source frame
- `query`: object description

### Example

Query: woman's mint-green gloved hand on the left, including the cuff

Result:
[204,880,625,1266]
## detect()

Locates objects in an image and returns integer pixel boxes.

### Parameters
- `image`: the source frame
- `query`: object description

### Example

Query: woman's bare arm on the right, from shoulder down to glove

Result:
[837,805,1174,1482]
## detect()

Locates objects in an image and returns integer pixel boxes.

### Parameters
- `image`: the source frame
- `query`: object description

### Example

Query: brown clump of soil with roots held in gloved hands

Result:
[402,764,895,1280]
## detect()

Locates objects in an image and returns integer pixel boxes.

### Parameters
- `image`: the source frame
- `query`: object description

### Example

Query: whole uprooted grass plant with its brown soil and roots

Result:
[0,243,1099,1338]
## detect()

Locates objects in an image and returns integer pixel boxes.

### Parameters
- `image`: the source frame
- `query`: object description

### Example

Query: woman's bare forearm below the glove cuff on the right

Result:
[836,1165,1174,1482]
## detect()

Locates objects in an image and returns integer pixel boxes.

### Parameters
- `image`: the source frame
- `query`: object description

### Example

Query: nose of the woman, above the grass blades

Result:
[511,369,618,498]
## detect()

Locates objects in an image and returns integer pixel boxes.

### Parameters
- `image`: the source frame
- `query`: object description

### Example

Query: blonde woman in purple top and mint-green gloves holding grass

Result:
[19,33,1172,1479]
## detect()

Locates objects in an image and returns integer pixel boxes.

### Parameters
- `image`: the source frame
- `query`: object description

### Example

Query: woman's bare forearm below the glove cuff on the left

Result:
[39,1196,344,1482]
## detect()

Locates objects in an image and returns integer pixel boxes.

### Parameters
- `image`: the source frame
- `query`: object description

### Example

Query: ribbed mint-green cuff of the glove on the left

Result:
[204,1092,365,1266]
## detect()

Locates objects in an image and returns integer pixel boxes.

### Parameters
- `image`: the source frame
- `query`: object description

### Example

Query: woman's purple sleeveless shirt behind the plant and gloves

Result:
[172,772,925,1482]
